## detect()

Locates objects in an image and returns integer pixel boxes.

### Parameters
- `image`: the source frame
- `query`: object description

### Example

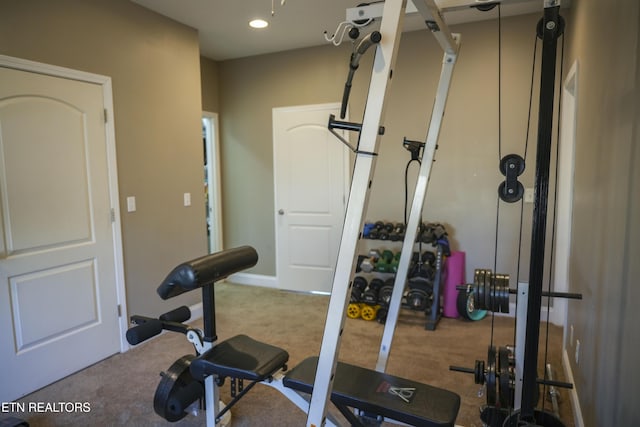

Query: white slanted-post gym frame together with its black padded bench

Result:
[128,0,460,427]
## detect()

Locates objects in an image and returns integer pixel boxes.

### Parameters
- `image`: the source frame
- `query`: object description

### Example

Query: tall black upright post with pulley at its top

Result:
[520,5,561,422]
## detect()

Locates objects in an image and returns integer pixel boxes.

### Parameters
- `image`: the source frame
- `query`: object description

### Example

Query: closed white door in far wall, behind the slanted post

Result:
[273,104,349,293]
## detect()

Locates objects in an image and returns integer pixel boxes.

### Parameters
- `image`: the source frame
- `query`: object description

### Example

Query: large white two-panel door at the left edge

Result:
[0,66,121,402]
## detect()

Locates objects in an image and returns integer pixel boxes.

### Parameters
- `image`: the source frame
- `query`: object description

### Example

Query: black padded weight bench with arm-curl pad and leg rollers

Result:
[127,246,460,427]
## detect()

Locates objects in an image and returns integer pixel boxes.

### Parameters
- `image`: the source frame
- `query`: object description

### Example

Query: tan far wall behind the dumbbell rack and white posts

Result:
[220,15,539,280]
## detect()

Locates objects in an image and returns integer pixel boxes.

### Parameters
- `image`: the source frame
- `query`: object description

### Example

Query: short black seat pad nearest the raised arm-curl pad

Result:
[190,335,289,381]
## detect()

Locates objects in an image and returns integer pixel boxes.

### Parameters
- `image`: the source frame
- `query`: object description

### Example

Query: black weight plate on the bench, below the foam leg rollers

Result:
[153,354,196,422]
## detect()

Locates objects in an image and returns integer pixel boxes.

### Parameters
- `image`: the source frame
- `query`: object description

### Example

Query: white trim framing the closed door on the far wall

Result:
[271,102,352,295]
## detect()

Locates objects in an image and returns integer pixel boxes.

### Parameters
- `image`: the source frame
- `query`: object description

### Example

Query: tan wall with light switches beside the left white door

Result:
[0,0,206,315]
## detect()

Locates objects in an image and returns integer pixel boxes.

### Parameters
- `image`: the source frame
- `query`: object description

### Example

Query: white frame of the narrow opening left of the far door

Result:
[202,111,223,252]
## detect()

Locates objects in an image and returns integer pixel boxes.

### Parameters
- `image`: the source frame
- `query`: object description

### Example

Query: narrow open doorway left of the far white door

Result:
[202,111,222,253]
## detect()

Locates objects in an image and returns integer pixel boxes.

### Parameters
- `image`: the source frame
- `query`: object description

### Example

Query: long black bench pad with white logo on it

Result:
[283,357,460,427]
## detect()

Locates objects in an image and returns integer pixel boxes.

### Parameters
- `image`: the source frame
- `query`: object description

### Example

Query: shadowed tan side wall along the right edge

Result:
[566,0,640,426]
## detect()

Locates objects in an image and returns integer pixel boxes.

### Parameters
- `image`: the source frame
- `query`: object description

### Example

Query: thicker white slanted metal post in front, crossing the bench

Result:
[306,0,406,427]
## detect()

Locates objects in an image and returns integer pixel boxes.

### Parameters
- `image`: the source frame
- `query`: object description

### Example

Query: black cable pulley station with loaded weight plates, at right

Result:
[451,0,582,427]
